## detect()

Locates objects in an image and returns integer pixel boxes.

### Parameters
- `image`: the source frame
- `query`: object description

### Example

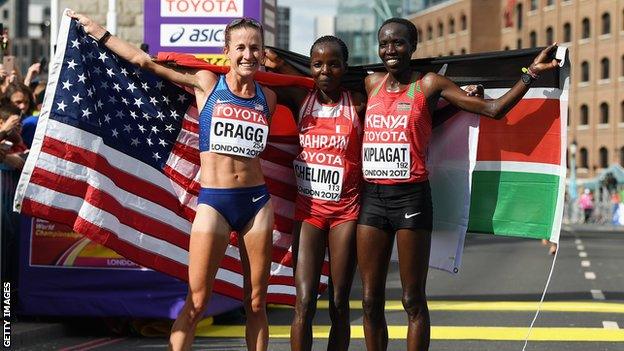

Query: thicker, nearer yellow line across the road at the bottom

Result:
[195,325,624,342]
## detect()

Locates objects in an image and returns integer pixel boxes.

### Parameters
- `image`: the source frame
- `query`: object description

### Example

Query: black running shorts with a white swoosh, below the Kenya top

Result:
[358,181,433,233]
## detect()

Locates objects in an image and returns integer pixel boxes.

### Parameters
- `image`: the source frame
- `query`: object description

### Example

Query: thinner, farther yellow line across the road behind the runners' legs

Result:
[271,300,624,313]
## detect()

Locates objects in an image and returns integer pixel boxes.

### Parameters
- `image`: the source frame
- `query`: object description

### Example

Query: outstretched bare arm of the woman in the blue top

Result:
[67,10,208,91]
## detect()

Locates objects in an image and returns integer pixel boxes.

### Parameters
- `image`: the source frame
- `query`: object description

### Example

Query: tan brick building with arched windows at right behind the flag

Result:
[409,0,624,178]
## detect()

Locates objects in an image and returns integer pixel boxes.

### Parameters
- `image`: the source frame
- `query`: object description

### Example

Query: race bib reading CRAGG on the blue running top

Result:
[209,99,269,158]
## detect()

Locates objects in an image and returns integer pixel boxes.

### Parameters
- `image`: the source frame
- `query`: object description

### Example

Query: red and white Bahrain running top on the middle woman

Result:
[293,90,362,206]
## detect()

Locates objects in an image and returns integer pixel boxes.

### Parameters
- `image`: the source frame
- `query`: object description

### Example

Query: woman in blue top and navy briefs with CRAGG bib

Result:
[69,11,276,351]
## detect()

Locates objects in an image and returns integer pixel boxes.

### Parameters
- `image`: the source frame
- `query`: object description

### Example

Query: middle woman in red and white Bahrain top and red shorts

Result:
[266,36,366,351]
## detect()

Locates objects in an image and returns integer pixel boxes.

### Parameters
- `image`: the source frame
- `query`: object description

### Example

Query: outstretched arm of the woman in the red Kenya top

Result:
[423,44,557,119]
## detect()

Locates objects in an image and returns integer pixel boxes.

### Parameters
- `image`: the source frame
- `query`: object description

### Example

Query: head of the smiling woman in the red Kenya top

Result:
[378,22,416,74]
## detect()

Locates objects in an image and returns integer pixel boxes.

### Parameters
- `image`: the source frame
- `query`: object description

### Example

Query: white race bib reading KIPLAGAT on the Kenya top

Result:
[362,143,411,179]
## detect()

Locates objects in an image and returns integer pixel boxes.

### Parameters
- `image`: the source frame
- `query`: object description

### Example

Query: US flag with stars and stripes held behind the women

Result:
[15,16,328,304]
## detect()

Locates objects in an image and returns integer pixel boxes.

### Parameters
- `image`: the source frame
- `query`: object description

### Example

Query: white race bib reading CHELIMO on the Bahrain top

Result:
[293,160,344,201]
